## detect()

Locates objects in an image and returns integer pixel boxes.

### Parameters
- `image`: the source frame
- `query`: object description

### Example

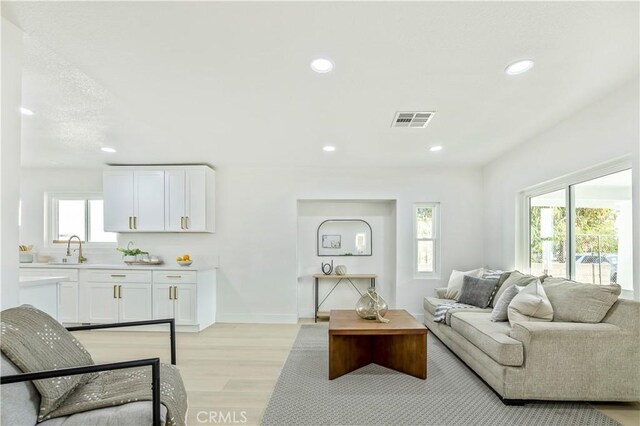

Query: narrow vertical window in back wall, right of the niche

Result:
[413,203,440,278]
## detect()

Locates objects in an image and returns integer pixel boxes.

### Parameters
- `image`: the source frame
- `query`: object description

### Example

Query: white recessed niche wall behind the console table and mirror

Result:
[297,200,396,318]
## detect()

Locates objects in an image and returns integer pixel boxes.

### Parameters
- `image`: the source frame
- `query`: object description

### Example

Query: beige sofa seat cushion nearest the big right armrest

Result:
[451,311,524,366]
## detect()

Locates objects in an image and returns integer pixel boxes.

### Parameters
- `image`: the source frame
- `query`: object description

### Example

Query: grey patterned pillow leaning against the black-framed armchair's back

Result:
[0,305,95,422]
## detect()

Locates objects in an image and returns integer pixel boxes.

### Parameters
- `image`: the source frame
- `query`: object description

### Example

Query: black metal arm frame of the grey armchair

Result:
[0,318,176,426]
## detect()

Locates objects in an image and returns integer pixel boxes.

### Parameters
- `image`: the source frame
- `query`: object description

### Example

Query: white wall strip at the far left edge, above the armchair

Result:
[0,18,22,309]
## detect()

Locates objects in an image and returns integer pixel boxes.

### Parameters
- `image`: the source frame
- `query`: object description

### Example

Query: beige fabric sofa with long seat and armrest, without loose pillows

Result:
[424,288,640,404]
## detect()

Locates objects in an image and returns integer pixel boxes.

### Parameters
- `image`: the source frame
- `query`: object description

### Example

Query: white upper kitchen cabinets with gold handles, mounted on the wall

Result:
[103,166,215,232]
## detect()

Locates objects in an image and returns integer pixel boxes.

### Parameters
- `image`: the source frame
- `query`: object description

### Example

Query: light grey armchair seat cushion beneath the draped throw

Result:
[38,401,167,426]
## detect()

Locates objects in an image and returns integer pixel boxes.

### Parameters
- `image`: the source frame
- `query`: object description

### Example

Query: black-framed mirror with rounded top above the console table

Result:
[317,219,371,256]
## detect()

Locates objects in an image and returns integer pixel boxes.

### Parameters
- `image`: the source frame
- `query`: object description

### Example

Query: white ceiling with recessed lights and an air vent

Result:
[2,2,639,167]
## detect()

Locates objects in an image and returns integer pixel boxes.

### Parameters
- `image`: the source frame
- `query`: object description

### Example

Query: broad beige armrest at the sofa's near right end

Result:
[510,322,640,401]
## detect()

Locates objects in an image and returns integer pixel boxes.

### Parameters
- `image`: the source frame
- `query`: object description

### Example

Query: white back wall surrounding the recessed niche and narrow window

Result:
[21,167,483,322]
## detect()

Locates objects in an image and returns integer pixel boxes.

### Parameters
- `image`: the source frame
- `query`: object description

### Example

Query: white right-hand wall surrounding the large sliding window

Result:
[483,79,640,298]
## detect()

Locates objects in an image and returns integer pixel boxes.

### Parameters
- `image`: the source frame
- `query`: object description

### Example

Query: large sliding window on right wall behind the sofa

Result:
[524,167,633,291]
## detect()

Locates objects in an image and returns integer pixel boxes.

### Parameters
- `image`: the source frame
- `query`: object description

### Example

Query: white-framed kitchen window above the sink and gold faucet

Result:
[46,193,117,246]
